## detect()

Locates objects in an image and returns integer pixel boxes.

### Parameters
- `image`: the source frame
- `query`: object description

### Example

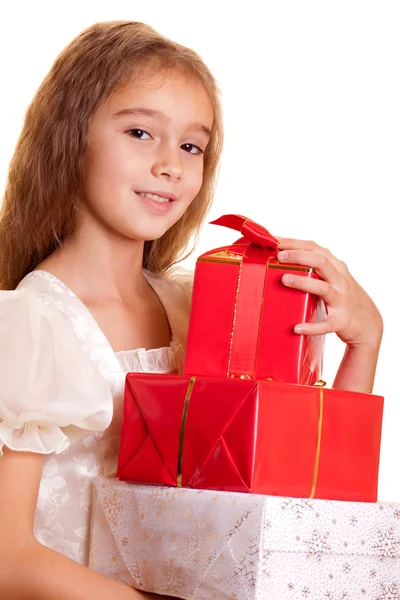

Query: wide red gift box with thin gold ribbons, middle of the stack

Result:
[118,373,383,502]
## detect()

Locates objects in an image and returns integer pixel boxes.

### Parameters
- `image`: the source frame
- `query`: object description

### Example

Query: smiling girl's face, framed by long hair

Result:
[84,74,213,241]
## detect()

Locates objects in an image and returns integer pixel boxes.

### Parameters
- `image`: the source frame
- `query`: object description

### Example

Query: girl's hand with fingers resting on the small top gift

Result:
[278,238,383,349]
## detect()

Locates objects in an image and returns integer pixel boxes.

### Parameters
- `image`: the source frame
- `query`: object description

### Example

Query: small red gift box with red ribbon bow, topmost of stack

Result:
[184,215,325,385]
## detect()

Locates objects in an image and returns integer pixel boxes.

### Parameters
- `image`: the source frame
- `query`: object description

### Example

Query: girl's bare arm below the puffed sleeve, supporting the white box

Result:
[0,448,174,600]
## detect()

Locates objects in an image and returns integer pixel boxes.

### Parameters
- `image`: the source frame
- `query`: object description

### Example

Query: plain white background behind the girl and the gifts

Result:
[0,0,400,501]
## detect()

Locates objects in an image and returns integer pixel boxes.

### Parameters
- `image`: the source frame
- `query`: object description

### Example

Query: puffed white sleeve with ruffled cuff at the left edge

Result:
[0,289,113,456]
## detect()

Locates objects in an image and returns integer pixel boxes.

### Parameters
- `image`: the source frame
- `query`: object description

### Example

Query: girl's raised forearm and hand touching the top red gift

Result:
[278,238,383,393]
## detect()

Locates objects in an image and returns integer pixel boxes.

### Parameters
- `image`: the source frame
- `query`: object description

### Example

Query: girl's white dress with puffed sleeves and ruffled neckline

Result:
[0,271,191,564]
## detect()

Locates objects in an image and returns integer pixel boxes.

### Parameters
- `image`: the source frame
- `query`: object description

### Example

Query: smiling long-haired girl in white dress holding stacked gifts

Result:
[0,22,382,600]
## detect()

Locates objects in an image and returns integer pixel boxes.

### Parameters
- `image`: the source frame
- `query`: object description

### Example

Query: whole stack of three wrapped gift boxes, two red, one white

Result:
[90,215,400,600]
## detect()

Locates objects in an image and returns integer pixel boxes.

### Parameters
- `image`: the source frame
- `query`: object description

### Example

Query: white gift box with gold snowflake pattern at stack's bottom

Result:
[90,479,400,600]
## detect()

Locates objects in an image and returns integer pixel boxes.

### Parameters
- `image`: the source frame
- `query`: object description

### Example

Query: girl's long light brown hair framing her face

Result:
[0,21,223,289]
